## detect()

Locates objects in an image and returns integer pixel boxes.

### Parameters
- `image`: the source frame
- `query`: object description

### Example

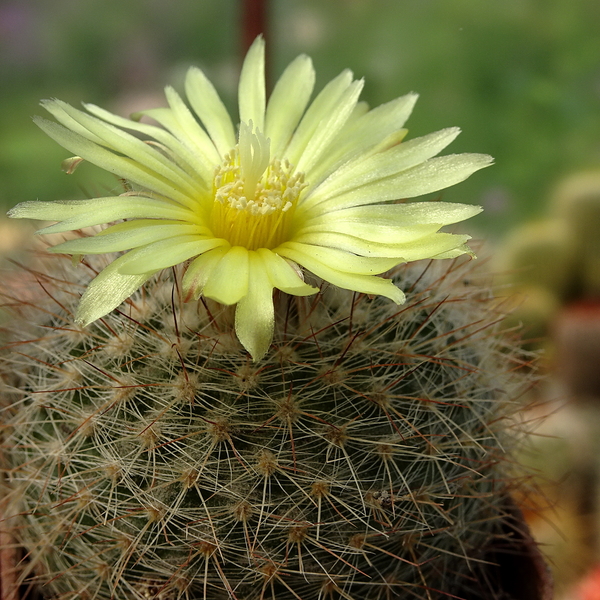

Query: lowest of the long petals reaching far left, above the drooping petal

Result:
[49,219,208,254]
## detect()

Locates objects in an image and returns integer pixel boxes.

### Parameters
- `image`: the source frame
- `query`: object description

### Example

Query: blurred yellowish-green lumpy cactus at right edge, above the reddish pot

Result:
[496,171,600,343]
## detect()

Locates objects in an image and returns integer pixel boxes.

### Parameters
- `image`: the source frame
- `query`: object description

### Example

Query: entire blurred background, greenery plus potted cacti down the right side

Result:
[0,0,600,600]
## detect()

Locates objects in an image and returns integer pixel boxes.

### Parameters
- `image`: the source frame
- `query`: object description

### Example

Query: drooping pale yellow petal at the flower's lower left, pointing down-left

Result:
[75,254,154,327]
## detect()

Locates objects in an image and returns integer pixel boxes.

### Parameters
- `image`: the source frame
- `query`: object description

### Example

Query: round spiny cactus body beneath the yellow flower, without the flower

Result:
[2,245,524,600]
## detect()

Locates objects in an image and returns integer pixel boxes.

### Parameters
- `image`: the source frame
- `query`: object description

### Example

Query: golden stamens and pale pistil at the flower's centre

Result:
[210,121,307,250]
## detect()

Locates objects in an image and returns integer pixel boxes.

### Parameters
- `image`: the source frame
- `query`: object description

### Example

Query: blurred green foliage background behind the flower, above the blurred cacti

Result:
[0,0,600,238]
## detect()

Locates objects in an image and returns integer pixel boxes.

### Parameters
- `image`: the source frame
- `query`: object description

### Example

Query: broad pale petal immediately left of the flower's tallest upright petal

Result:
[185,67,236,158]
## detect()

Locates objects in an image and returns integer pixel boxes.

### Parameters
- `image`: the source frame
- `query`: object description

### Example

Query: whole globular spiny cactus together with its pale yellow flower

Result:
[2,37,522,600]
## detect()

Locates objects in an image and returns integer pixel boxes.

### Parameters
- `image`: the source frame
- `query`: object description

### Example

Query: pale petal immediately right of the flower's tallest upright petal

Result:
[265,54,315,158]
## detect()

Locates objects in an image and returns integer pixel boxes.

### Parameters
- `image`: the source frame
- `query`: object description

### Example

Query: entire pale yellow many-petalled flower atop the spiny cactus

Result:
[9,38,491,360]
